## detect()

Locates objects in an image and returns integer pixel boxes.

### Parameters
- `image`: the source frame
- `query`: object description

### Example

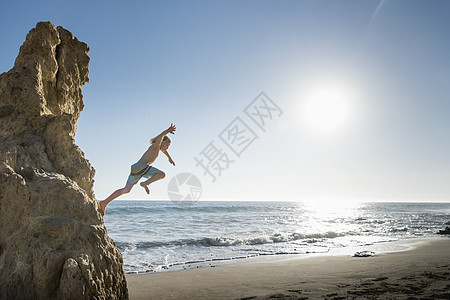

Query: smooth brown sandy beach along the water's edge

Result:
[127,239,450,299]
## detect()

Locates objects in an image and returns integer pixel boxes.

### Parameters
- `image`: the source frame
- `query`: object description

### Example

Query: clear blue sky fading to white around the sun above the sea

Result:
[0,0,450,203]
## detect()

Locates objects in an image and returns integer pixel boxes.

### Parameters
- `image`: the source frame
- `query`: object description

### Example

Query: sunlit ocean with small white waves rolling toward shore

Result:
[104,200,450,274]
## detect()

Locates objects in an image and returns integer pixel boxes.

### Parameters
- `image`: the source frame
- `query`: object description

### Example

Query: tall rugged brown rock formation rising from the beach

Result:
[0,22,128,299]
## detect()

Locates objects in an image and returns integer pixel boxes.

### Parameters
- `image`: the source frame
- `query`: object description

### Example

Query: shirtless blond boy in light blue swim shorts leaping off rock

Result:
[99,124,176,215]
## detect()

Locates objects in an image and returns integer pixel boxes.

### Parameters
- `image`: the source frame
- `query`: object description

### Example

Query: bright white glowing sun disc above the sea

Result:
[302,87,352,133]
